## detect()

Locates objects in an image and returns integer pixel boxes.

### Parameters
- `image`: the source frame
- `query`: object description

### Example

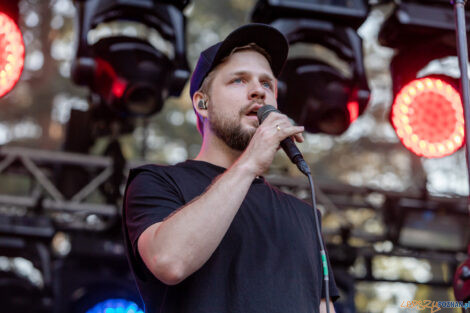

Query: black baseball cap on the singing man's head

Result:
[189,23,289,99]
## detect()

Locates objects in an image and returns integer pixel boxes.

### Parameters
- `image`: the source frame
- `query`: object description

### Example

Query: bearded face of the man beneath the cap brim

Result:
[208,50,277,151]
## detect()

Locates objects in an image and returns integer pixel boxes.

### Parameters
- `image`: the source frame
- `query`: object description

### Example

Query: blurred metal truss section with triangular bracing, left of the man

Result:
[0,147,148,230]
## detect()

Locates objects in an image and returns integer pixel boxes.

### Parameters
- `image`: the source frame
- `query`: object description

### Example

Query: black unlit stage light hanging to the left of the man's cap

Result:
[72,0,189,118]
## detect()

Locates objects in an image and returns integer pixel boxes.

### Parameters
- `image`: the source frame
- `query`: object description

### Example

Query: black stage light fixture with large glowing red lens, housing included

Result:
[379,1,465,158]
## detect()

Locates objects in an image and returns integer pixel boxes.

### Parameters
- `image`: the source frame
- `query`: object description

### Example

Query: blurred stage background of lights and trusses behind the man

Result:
[0,0,470,313]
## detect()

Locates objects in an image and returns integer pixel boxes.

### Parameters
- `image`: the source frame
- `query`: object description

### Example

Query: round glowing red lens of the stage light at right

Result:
[391,77,464,158]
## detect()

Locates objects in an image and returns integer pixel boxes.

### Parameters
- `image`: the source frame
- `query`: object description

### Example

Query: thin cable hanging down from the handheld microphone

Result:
[298,165,330,313]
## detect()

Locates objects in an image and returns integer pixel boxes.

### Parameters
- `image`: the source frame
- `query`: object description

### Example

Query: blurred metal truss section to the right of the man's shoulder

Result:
[267,176,470,287]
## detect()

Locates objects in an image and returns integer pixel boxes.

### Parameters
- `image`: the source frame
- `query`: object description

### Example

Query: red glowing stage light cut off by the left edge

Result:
[0,12,24,97]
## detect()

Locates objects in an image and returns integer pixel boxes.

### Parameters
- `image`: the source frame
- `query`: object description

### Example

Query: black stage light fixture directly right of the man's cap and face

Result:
[252,0,370,135]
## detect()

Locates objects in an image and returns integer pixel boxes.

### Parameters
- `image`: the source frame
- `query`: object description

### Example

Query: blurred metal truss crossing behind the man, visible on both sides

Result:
[0,147,468,286]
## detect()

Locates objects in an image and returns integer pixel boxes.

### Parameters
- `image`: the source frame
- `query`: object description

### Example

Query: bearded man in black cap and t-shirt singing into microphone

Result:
[123,24,338,313]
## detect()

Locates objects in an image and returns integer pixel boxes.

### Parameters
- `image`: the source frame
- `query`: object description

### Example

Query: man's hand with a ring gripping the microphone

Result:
[237,112,304,175]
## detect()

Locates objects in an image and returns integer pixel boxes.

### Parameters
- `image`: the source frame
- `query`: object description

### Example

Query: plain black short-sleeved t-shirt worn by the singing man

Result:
[123,160,338,313]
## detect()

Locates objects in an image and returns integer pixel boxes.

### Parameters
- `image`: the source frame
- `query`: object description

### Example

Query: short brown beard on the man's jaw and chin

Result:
[209,106,255,151]
